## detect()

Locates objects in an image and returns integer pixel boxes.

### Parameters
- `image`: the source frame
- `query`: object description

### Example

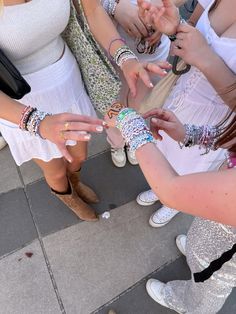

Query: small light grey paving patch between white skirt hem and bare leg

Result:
[19,161,43,185]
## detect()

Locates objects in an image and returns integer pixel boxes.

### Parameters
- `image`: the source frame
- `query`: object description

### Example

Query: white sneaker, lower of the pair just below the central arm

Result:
[149,206,178,228]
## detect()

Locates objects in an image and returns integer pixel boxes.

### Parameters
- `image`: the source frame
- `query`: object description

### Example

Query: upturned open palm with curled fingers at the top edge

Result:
[138,0,180,35]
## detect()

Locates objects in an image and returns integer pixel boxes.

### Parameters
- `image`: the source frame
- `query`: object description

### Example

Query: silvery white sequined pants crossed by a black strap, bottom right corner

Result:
[164,218,236,314]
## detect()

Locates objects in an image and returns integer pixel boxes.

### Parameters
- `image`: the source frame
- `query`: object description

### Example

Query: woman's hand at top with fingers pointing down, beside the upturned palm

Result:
[114,0,148,38]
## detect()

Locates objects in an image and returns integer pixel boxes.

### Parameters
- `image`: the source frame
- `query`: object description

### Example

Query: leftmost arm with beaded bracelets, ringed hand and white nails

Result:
[0,92,106,162]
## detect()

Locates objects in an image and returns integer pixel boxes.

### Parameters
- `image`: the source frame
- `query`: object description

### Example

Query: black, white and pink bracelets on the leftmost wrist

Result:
[19,106,50,138]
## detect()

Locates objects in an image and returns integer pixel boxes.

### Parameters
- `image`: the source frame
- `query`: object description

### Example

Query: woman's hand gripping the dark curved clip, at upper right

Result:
[171,24,213,68]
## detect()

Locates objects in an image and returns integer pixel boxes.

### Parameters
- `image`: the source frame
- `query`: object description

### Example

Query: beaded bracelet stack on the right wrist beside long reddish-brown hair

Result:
[180,124,220,154]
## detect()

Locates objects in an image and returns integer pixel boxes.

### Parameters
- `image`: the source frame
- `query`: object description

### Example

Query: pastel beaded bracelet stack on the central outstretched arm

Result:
[116,108,155,152]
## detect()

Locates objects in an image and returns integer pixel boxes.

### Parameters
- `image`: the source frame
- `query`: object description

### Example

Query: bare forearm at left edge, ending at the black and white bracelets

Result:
[0,92,25,124]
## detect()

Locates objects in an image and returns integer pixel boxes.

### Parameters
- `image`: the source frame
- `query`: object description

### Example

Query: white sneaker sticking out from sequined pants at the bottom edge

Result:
[146,279,182,314]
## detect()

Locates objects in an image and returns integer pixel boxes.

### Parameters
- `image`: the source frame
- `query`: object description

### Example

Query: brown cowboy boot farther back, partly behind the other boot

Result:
[68,171,99,204]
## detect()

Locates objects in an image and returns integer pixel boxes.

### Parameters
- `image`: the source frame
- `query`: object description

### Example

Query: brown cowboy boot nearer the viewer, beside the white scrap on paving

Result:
[51,185,98,221]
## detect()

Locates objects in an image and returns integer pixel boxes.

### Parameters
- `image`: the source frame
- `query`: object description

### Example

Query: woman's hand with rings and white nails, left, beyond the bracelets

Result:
[39,113,106,162]
